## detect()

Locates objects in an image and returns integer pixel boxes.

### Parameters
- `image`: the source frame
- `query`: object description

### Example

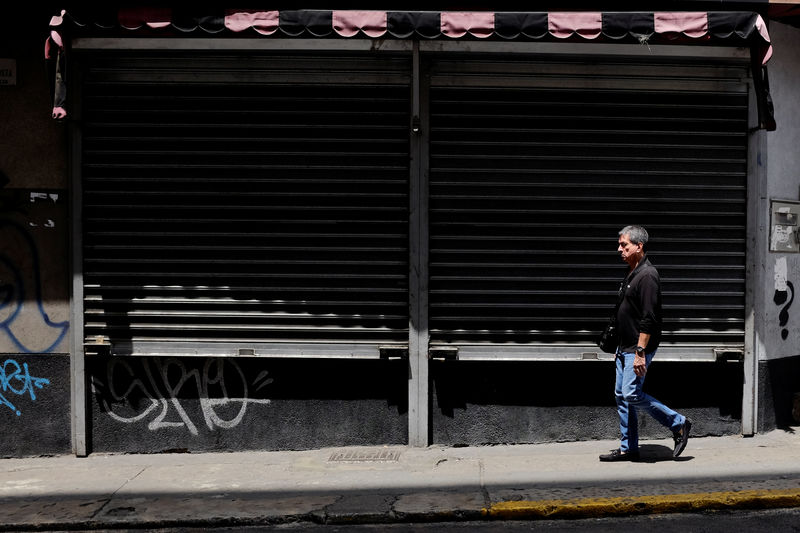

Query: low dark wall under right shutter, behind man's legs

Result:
[431,359,743,446]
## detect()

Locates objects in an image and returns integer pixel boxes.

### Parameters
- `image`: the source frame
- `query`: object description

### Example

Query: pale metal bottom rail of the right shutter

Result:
[430,344,744,363]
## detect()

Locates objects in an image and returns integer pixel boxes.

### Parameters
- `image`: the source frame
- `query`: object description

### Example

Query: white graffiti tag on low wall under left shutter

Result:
[92,358,272,436]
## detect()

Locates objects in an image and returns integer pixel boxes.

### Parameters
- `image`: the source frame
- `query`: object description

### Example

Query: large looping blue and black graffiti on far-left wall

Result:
[0,191,69,353]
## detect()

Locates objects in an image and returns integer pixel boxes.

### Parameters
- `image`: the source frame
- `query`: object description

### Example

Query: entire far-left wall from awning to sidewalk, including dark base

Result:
[0,9,71,457]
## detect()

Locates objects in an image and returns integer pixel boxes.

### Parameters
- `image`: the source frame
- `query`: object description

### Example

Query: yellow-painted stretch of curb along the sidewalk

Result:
[483,489,800,519]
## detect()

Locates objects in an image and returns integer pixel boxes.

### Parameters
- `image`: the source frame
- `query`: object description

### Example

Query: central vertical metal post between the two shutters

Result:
[408,41,430,446]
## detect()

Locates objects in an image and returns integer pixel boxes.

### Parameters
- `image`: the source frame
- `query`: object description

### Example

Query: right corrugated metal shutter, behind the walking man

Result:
[428,56,748,359]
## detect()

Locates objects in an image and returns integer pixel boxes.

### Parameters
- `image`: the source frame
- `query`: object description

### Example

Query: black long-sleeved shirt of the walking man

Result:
[617,256,661,353]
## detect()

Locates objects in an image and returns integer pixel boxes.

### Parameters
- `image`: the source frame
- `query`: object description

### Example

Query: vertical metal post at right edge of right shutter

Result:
[742,80,768,435]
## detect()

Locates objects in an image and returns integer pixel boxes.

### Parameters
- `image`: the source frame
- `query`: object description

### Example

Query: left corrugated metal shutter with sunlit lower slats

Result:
[81,50,410,357]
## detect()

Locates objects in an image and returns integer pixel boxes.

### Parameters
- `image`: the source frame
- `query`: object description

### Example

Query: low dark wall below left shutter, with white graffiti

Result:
[88,357,408,452]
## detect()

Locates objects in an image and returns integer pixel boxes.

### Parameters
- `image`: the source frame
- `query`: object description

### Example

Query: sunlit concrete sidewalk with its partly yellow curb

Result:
[0,431,800,531]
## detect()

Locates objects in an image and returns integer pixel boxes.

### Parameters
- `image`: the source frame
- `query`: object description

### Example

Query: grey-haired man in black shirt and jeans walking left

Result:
[600,226,692,461]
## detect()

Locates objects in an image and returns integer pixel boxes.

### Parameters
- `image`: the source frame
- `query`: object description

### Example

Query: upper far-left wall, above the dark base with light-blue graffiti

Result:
[0,14,69,353]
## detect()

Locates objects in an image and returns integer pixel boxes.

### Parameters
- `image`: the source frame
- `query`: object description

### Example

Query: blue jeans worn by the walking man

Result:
[614,352,686,452]
